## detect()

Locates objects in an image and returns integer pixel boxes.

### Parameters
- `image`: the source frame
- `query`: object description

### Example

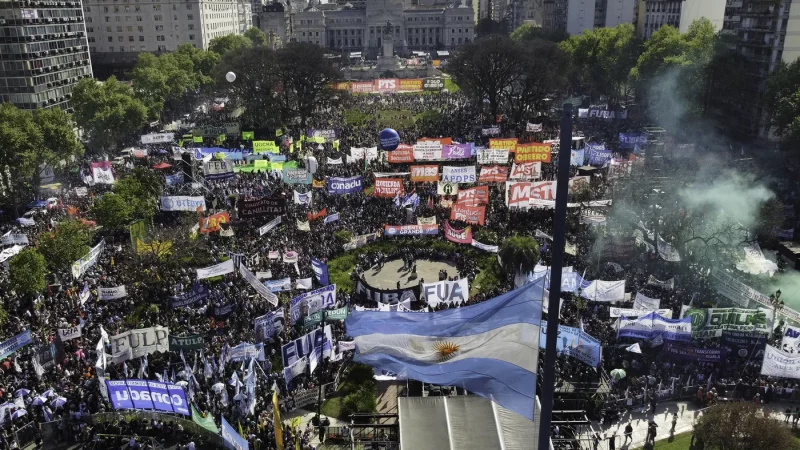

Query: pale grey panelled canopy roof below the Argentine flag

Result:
[397,395,553,450]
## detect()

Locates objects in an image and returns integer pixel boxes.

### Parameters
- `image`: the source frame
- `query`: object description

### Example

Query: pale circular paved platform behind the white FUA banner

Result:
[362,259,459,289]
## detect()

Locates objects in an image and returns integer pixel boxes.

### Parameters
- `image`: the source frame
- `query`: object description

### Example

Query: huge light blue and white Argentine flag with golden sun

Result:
[345,283,542,420]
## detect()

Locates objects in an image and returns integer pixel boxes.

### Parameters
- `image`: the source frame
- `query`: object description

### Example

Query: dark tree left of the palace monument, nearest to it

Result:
[277,42,339,128]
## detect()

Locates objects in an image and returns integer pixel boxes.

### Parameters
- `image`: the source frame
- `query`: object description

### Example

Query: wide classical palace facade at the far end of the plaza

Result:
[261,0,475,58]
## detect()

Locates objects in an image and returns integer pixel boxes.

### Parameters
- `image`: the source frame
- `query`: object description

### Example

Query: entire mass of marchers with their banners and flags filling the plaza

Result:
[0,89,800,450]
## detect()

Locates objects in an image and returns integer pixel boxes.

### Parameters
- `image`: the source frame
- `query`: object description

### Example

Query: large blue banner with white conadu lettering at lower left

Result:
[106,380,190,416]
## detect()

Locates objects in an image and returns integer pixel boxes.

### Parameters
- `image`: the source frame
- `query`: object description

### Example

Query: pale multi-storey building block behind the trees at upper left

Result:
[84,0,253,78]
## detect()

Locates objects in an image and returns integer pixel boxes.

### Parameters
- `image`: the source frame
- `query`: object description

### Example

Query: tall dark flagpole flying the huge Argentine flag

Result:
[534,103,572,450]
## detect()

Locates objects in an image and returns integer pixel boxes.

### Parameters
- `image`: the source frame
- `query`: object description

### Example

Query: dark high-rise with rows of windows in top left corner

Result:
[0,0,92,110]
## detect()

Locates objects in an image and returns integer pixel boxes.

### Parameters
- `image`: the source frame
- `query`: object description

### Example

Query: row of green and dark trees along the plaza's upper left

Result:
[72,28,339,155]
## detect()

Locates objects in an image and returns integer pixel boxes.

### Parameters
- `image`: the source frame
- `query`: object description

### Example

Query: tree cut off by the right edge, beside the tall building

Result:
[764,59,800,142]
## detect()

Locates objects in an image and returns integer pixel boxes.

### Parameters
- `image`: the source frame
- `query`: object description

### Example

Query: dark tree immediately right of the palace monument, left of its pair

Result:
[448,35,523,119]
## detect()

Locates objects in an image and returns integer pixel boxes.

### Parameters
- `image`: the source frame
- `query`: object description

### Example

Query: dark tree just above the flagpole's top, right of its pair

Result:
[502,39,570,132]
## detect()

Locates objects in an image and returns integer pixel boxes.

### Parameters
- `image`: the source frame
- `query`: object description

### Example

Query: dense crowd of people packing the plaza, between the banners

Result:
[0,88,798,449]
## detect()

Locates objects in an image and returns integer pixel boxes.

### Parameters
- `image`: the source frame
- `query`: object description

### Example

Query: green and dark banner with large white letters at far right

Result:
[686,308,774,339]
